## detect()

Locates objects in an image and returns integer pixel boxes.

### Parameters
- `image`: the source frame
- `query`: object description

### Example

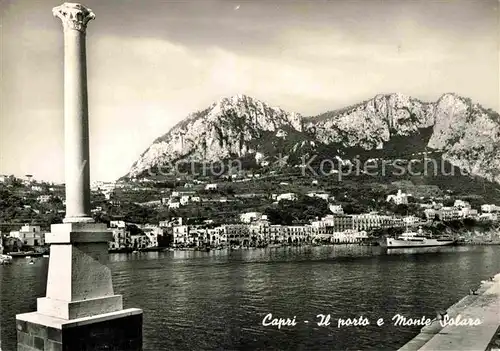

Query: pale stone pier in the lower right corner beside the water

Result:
[399,273,500,351]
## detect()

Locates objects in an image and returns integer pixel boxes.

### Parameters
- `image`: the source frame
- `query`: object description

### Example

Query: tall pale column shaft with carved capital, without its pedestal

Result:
[52,3,95,222]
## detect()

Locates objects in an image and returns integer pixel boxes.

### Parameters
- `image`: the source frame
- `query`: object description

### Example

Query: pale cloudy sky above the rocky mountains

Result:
[0,0,500,182]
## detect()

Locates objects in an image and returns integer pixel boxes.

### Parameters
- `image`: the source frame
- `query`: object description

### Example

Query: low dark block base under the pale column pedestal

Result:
[16,308,142,351]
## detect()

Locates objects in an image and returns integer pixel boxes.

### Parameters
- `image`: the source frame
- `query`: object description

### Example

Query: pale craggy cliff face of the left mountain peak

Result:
[129,95,302,177]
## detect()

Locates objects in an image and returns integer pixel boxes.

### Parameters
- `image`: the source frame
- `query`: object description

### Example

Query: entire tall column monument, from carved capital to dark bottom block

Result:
[16,3,142,351]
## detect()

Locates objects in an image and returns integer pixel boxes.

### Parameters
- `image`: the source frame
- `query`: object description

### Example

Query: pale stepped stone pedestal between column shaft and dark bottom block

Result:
[37,223,123,319]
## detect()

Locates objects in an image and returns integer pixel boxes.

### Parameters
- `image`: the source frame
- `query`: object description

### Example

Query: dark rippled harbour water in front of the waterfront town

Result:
[0,245,500,351]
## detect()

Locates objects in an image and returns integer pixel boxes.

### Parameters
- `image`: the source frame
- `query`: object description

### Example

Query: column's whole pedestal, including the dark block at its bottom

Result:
[16,223,142,351]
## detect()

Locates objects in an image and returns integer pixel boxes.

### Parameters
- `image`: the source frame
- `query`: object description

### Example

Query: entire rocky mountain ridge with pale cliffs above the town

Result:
[127,93,500,187]
